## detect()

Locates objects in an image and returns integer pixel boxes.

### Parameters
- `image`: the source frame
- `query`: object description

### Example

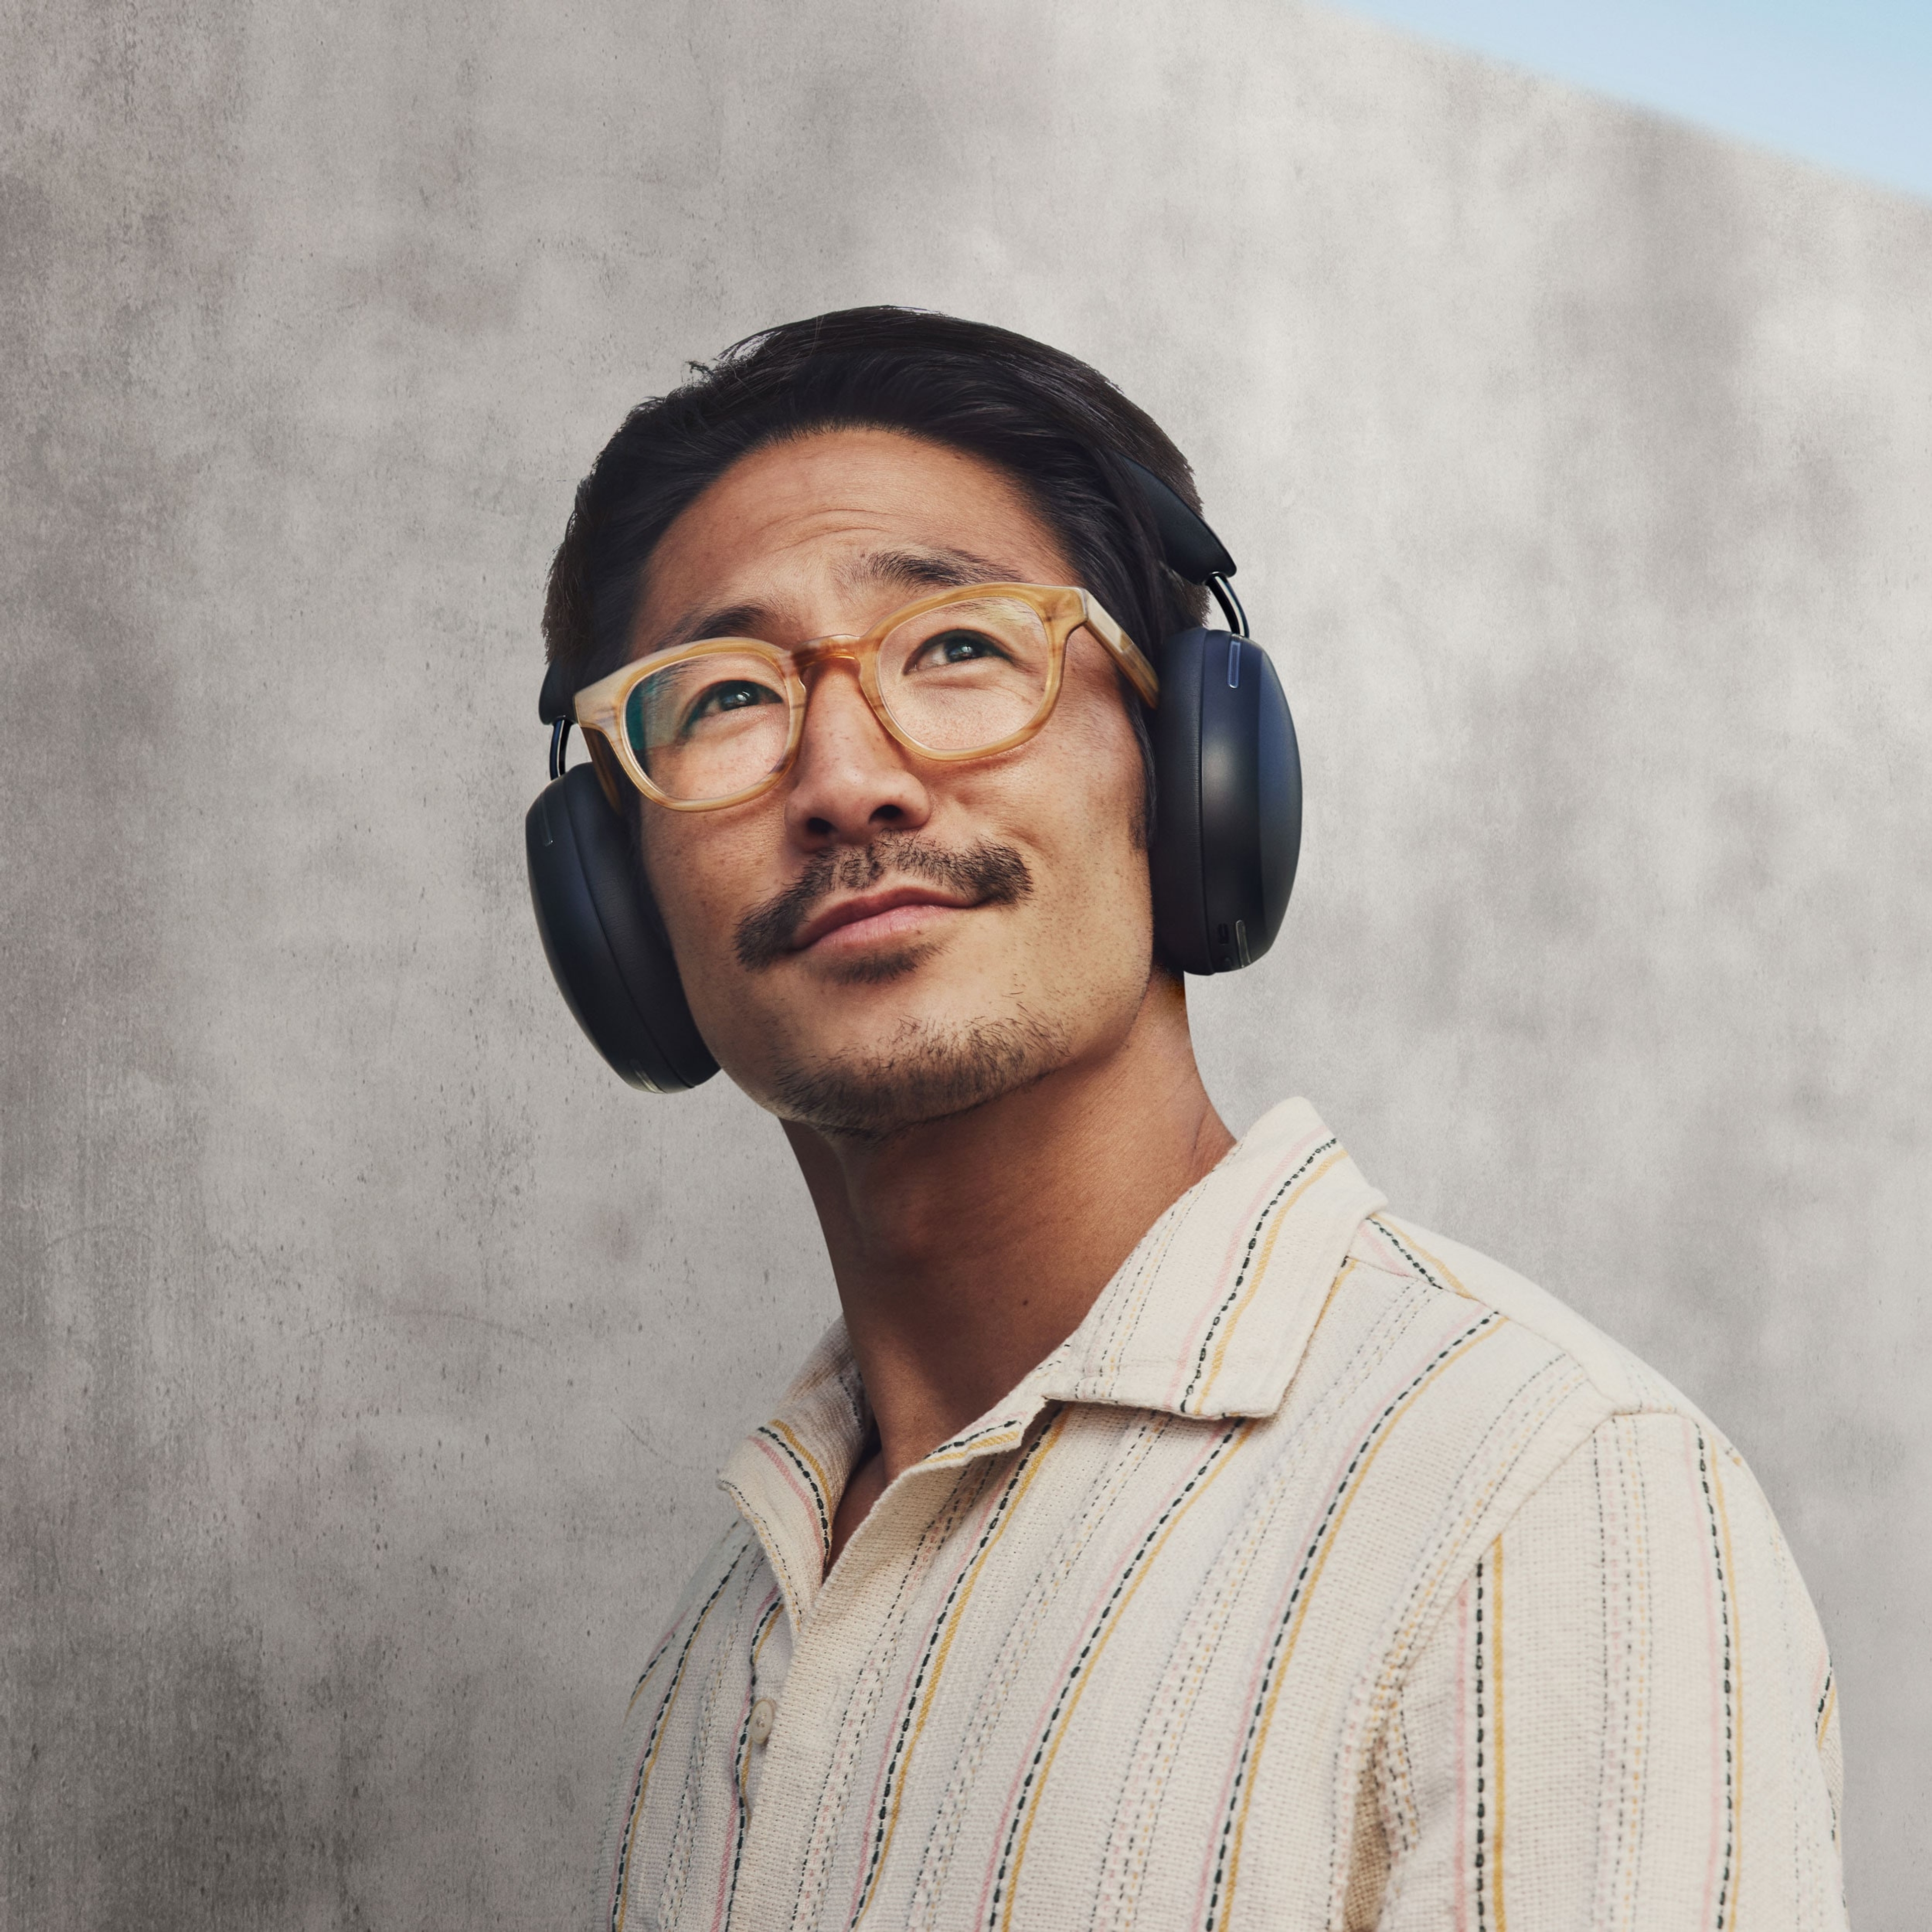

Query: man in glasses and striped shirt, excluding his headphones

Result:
[547,311,1843,1932]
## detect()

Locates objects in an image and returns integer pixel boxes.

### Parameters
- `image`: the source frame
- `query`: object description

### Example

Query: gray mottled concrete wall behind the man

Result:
[0,0,1932,1932]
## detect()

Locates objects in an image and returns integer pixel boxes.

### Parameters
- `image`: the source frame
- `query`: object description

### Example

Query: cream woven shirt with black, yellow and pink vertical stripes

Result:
[597,1101,1845,1932]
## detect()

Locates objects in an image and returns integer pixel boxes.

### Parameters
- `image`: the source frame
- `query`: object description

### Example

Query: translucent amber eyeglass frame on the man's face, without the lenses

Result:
[576,584,1161,812]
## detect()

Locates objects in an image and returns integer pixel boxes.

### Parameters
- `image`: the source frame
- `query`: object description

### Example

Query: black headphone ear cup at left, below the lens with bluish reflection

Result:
[524,765,718,1093]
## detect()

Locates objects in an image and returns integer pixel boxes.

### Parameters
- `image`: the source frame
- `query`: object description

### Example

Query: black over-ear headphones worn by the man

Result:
[524,456,1302,1093]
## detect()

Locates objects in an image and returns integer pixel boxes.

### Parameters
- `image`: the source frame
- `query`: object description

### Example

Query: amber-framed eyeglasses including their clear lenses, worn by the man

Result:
[576,584,1161,812]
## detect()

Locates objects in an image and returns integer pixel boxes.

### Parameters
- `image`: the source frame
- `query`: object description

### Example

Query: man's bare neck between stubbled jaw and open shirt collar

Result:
[786,978,1235,1491]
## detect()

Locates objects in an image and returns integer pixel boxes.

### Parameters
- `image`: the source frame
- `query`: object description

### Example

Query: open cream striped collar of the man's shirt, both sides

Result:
[718,1099,1383,1619]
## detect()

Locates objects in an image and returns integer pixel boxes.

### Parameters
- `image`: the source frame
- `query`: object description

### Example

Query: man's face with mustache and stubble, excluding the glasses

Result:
[632,429,1152,1136]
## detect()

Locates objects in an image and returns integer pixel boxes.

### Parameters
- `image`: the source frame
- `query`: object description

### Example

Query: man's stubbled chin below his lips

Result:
[767,1004,1072,1142]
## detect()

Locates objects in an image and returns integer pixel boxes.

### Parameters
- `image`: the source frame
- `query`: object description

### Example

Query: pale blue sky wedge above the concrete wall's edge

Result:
[1339,0,1932,199]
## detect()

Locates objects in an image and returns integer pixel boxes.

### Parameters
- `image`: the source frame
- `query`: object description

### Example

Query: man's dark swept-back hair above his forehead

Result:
[543,307,1205,711]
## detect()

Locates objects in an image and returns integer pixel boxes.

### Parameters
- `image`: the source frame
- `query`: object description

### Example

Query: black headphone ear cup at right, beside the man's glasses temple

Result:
[1150,630,1302,974]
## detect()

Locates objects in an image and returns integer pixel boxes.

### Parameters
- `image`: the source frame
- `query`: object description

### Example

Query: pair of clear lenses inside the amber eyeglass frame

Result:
[624,597,1053,803]
